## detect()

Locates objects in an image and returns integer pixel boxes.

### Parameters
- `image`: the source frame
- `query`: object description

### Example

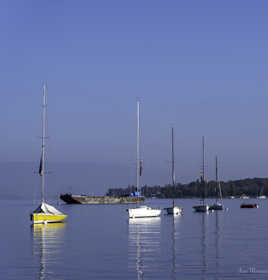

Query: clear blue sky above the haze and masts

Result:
[0,0,268,187]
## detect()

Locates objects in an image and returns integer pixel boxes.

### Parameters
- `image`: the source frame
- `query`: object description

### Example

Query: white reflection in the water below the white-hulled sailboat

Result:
[128,217,161,279]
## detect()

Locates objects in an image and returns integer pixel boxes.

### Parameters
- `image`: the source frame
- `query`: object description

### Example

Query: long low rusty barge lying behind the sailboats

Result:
[60,194,144,204]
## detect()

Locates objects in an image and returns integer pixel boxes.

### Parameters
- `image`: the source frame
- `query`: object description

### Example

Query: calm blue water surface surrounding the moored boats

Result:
[0,199,268,280]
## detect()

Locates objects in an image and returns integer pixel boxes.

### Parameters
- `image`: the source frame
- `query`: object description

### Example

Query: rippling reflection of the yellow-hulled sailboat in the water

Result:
[32,223,66,279]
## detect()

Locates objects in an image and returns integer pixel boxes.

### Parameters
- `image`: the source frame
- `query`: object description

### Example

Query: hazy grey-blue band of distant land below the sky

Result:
[0,158,265,202]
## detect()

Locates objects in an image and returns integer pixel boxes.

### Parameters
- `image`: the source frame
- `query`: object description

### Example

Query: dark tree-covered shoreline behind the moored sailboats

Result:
[107,178,268,198]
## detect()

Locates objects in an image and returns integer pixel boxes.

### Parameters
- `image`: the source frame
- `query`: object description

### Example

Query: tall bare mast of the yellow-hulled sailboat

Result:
[41,84,46,203]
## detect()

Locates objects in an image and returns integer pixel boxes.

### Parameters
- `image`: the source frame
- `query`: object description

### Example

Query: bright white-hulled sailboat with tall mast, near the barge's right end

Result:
[127,101,161,218]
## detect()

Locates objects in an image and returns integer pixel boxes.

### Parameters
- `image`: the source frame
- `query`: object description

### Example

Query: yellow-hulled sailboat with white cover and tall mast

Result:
[30,84,67,224]
